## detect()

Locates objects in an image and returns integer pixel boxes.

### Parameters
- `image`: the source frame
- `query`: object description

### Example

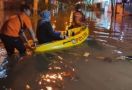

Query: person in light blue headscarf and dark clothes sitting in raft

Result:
[36,10,62,44]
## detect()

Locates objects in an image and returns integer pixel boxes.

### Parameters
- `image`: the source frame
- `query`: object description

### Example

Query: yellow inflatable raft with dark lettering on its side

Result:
[34,26,89,53]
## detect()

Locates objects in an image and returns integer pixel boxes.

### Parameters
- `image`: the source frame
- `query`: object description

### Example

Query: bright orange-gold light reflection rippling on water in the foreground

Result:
[30,55,75,90]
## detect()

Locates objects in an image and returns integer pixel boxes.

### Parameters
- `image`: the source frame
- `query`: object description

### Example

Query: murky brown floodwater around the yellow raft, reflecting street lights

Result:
[0,4,132,90]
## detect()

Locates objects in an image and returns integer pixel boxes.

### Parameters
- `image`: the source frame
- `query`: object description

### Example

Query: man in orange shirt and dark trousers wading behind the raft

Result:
[0,5,37,57]
